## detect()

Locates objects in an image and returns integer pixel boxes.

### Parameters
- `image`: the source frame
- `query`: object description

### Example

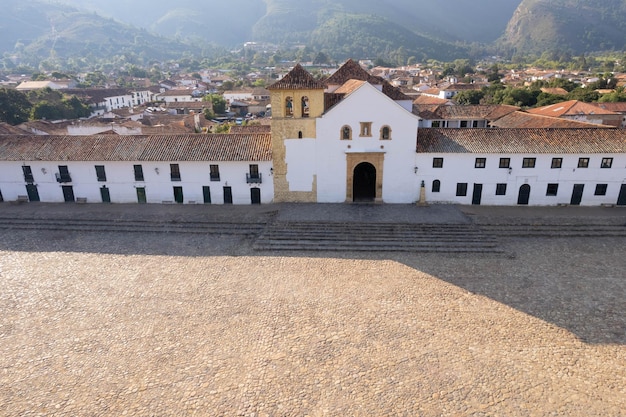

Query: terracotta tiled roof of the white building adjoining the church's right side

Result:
[417,128,626,154]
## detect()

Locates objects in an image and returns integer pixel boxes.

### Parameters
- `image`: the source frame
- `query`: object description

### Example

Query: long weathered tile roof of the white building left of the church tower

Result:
[0,133,272,161]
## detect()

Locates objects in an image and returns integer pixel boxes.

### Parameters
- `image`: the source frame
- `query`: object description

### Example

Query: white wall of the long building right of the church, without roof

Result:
[417,153,626,206]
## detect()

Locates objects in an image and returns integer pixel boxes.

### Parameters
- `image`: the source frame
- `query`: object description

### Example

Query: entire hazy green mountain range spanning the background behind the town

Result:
[0,0,626,66]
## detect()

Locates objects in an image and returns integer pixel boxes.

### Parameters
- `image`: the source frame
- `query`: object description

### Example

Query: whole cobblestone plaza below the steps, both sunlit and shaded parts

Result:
[0,231,626,417]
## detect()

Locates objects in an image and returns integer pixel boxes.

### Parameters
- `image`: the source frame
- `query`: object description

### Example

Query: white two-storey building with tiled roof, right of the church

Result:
[417,128,626,206]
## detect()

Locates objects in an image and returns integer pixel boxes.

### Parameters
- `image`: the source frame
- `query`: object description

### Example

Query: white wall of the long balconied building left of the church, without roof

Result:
[0,161,274,204]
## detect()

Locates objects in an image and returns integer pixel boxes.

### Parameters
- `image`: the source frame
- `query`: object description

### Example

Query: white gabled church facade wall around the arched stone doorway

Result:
[285,84,419,203]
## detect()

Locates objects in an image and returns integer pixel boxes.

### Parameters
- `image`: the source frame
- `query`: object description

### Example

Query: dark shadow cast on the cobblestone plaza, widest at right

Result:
[0,202,626,345]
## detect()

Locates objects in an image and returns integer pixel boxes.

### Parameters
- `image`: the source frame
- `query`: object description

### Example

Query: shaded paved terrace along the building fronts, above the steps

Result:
[0,203,626,224]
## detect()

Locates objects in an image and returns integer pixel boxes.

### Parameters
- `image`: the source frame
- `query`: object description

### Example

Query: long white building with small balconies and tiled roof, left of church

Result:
[0,134,274,204]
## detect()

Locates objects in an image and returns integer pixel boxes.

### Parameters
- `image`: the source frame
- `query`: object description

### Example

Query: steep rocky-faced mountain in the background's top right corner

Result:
[500,0,626,54]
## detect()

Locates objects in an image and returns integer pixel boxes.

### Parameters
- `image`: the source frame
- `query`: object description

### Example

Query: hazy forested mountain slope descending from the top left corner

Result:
[0,0,222,67]
